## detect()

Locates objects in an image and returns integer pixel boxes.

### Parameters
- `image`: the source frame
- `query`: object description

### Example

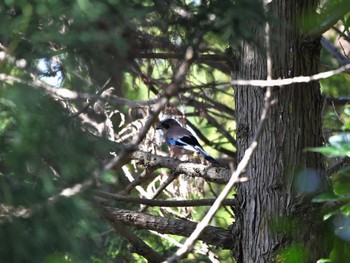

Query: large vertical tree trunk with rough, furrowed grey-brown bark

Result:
[233,0,324,263]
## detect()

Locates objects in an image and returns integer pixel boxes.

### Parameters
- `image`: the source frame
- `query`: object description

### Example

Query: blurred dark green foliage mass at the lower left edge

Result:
[0,81,114,262]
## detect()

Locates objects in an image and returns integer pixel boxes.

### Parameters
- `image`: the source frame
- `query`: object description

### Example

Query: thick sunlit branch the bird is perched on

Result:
[131,151,231,184]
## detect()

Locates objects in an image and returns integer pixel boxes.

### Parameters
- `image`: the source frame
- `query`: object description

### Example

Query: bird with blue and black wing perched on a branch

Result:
[156,118,218,164]
